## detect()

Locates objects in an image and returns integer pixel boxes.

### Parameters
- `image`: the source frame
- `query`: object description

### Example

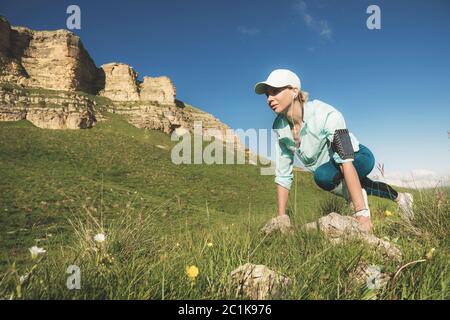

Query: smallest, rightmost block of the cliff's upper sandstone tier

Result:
[140,77,176,104]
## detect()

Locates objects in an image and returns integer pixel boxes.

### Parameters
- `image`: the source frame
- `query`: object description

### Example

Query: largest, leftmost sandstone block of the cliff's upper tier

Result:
[0,19,97,93]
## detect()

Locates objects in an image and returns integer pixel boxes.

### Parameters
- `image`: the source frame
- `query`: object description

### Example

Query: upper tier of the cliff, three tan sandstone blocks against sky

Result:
[0,17,176,104]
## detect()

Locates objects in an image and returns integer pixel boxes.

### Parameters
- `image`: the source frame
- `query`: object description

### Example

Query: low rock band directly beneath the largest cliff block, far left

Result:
[0,90,96,129]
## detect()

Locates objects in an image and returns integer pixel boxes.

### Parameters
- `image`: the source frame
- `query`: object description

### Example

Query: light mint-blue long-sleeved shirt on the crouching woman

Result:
[272,100,359,190]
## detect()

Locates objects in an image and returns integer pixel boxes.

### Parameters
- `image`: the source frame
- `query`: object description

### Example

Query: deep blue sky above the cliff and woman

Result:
[0,0,450,184]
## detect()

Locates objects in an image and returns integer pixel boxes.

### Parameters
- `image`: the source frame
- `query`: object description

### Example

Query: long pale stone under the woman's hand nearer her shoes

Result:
[303,212,402,261]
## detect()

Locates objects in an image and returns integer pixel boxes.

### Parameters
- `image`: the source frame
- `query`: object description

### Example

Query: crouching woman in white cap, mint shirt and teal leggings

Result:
[255,69,413,231]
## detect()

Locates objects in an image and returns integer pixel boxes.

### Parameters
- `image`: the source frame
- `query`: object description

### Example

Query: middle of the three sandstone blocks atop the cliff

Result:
[99,63,139,101]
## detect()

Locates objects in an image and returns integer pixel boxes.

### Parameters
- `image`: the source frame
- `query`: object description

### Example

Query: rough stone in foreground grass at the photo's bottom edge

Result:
[231,263,292,300]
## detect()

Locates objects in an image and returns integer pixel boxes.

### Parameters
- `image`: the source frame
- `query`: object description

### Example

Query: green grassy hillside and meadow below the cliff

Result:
[0,114,450,299]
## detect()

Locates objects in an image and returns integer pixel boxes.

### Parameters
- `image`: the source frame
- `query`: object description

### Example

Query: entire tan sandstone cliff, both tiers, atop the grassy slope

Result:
[0,17,239,144]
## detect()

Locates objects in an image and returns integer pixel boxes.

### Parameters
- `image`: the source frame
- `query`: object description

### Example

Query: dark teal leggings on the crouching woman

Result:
[314,144,398,200]
